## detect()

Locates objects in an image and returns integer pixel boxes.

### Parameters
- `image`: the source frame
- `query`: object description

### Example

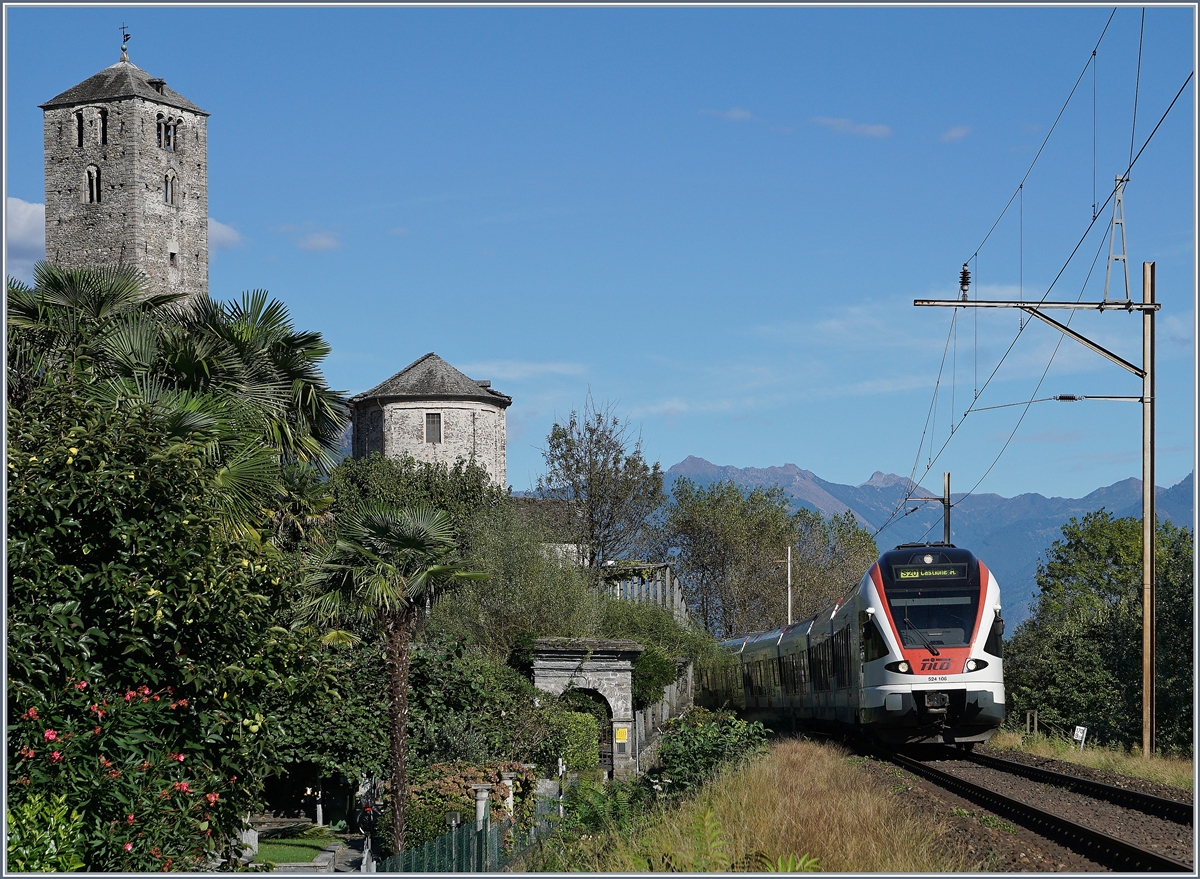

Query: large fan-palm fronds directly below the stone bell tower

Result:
[7,262,349,533]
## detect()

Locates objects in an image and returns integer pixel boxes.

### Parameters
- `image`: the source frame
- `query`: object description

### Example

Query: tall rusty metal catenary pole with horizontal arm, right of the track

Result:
[913,262,1162,757]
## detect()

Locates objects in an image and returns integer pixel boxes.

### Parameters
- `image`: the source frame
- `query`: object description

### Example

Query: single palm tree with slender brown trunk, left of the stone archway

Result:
[298,504,487,851]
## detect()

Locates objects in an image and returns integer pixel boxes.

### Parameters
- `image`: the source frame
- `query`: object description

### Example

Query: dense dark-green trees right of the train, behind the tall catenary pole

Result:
[1004,510,1194,753]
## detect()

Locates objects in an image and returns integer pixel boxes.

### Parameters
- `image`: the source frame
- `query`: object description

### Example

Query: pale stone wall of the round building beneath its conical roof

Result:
[353,400,508,488]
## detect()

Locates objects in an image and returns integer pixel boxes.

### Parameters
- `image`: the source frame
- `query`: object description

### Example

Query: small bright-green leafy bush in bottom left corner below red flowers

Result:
[6,794,84,873]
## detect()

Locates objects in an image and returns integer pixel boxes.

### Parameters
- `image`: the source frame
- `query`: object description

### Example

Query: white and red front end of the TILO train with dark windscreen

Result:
[859,545,1004,748]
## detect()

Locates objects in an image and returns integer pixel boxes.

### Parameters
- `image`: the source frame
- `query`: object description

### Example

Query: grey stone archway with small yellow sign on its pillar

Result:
[533,638,644,778]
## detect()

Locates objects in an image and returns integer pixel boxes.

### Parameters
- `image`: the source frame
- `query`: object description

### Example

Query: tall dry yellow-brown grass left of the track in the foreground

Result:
[595,739,968,873]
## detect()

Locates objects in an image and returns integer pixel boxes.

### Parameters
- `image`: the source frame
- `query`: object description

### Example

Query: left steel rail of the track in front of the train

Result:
[887,754,1195,873]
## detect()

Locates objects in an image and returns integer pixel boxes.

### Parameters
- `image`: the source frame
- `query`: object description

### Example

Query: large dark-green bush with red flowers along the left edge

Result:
[6,385,290,871]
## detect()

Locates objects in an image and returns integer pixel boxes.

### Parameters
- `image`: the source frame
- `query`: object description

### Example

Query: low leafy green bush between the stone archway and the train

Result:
[656,707,767,793]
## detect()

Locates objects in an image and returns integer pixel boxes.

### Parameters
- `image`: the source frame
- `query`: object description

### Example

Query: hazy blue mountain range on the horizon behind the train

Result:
[665,456,1193,630]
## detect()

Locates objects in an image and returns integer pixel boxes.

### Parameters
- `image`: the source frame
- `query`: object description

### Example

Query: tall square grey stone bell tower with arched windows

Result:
[41,36,209,298]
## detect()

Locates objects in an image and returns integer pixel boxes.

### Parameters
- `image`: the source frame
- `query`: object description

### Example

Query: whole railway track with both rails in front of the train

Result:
[886,752,1194,873]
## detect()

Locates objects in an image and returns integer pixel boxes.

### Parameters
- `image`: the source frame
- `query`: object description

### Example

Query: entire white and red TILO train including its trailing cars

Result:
[698,544,1004,749]
